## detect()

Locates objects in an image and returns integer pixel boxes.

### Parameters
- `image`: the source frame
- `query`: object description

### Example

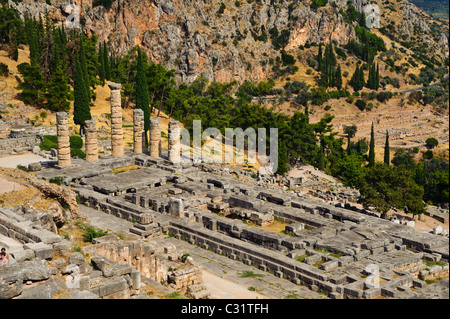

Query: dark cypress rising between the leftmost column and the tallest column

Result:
[73,58,91,133]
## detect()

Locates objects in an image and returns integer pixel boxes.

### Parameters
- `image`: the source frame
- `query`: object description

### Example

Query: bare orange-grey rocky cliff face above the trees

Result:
[9,0,448,82]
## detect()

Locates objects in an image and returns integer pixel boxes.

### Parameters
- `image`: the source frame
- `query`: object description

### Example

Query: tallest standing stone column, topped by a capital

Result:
[108,83,123,157]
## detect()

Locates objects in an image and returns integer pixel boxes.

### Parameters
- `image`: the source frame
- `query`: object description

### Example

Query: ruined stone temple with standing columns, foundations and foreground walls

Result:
[0,81,449,299]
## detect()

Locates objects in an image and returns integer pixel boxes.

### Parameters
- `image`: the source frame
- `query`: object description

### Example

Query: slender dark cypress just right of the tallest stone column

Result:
[135,48,150,146]
